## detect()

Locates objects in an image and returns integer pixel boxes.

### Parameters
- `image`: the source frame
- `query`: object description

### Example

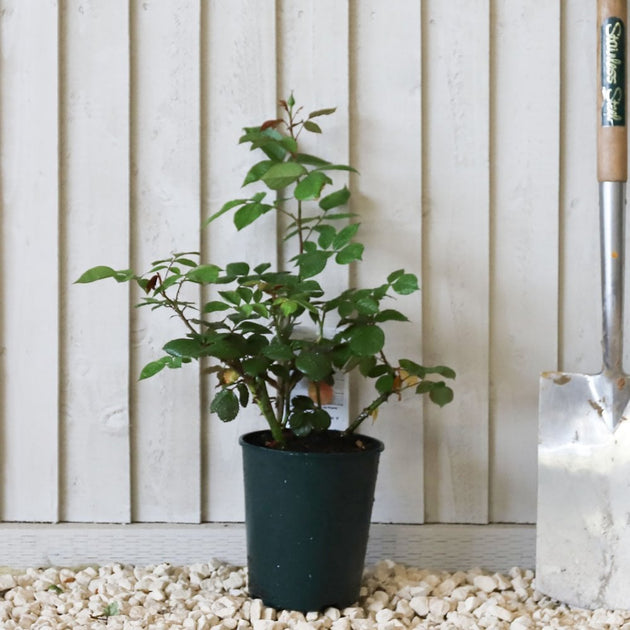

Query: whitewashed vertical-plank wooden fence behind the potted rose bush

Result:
[0,0,600,523]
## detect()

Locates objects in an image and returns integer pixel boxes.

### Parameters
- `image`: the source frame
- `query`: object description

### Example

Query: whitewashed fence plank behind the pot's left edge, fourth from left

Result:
[202,0,277,521]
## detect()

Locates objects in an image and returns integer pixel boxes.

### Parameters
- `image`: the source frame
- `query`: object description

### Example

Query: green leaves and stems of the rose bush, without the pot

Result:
[77,96,455,443]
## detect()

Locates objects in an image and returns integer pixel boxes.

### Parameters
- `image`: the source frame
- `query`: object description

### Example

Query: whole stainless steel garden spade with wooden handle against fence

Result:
[536,0,630,609]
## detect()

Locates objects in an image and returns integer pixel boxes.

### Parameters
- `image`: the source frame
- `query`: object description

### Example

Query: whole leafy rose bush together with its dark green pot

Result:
[77,96,455,610]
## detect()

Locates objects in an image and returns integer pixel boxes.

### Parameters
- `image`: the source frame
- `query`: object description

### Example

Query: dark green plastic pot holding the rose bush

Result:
[240,431,383,611]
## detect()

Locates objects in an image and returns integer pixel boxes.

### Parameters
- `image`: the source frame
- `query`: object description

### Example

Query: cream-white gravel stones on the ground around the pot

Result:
[0,560,630,630]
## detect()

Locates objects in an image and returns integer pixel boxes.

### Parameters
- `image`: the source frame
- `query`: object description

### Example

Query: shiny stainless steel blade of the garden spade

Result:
[536,372,630,609]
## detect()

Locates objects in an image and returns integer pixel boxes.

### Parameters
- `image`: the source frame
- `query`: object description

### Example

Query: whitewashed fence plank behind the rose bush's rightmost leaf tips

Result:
[422,0,490,523]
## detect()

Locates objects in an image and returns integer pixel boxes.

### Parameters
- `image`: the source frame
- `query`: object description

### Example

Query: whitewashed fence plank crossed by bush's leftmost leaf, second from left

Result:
[61,0,130,522]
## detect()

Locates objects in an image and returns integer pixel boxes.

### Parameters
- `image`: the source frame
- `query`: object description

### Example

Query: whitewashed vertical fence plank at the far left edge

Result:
[0,0,59,521]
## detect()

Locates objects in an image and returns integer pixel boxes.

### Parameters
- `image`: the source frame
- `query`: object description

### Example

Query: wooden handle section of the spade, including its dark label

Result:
[597,0,628,182]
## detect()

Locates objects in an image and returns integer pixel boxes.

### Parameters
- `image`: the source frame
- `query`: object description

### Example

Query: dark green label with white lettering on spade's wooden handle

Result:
[601,17,626,127]
